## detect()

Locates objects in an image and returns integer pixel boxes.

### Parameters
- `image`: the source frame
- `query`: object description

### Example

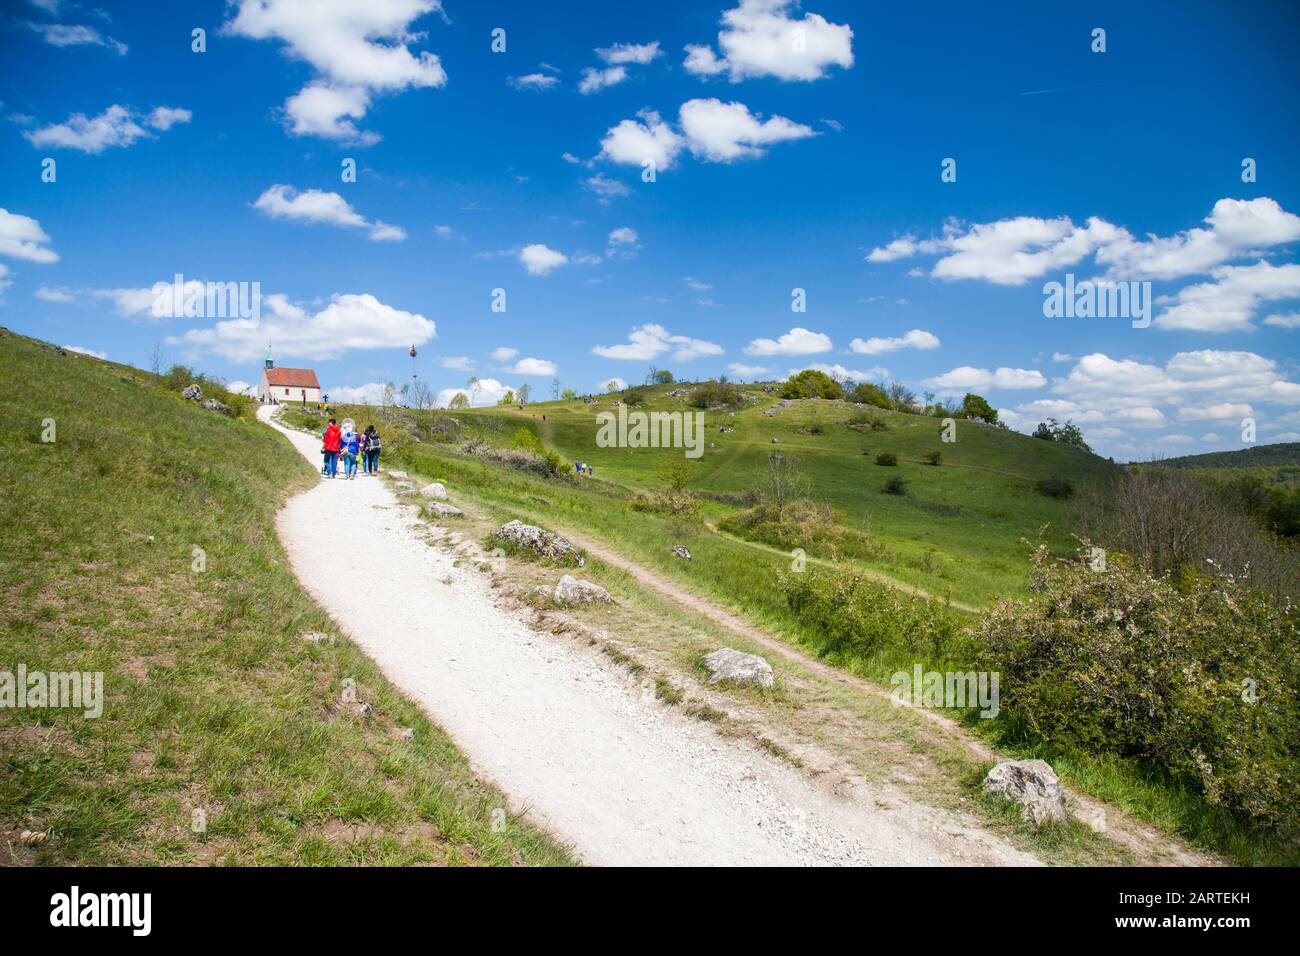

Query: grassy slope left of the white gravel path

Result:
[0,333,568,864]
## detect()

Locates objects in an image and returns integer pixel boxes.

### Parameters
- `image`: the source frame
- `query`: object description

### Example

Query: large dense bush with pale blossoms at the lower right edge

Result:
[975,549,1300,835]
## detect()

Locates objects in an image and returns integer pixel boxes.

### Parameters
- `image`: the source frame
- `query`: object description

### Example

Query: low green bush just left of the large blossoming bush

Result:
[781,571,962,658]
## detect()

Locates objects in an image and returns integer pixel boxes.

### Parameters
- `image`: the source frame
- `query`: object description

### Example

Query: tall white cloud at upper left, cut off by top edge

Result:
[224,0,447,144]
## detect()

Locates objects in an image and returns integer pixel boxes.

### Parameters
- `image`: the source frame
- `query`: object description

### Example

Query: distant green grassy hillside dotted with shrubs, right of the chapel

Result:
[458,385,1114,605]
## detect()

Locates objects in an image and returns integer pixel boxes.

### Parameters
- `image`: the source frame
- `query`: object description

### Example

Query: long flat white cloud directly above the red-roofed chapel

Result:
[166,294,437,362]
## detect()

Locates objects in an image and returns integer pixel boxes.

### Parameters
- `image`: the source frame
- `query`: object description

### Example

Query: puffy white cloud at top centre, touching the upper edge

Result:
[684,0,853,83]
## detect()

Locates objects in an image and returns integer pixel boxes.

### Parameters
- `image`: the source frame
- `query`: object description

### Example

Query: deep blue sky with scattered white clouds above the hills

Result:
[0,0,1300,459]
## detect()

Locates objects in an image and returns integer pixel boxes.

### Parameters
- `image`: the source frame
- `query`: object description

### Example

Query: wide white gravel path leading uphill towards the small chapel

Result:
[259,408,1036,865]
